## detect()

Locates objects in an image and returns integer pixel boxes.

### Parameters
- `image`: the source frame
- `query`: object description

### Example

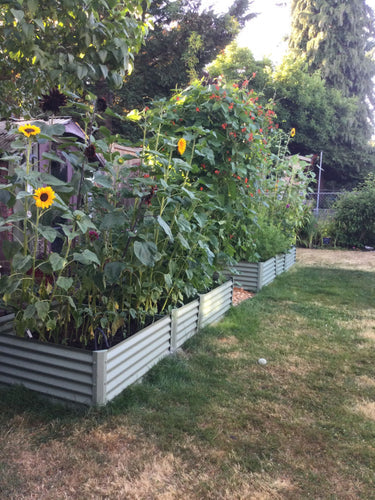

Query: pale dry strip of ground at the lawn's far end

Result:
[297,248,375,271]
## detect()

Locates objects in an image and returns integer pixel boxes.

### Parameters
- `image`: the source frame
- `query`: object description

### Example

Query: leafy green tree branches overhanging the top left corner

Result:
[0,0,148,117]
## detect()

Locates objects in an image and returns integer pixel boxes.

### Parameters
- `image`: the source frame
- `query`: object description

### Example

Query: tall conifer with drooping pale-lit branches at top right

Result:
[289,0,375,109]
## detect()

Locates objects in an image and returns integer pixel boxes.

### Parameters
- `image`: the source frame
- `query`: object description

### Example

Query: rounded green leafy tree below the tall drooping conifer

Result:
[272,56,374,188]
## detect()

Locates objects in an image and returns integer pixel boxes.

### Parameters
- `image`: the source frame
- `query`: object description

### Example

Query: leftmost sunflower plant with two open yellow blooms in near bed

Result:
[0,123,101,340]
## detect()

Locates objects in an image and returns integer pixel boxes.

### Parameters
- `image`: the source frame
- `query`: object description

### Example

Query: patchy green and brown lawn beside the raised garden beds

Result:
[0,265,375,500]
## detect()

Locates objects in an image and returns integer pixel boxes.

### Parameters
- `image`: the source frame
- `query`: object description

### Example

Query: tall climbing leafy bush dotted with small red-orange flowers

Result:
[134,81,312,261]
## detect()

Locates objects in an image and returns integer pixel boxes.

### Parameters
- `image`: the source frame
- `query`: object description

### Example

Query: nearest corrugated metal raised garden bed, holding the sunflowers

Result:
[0,280,233,405]
